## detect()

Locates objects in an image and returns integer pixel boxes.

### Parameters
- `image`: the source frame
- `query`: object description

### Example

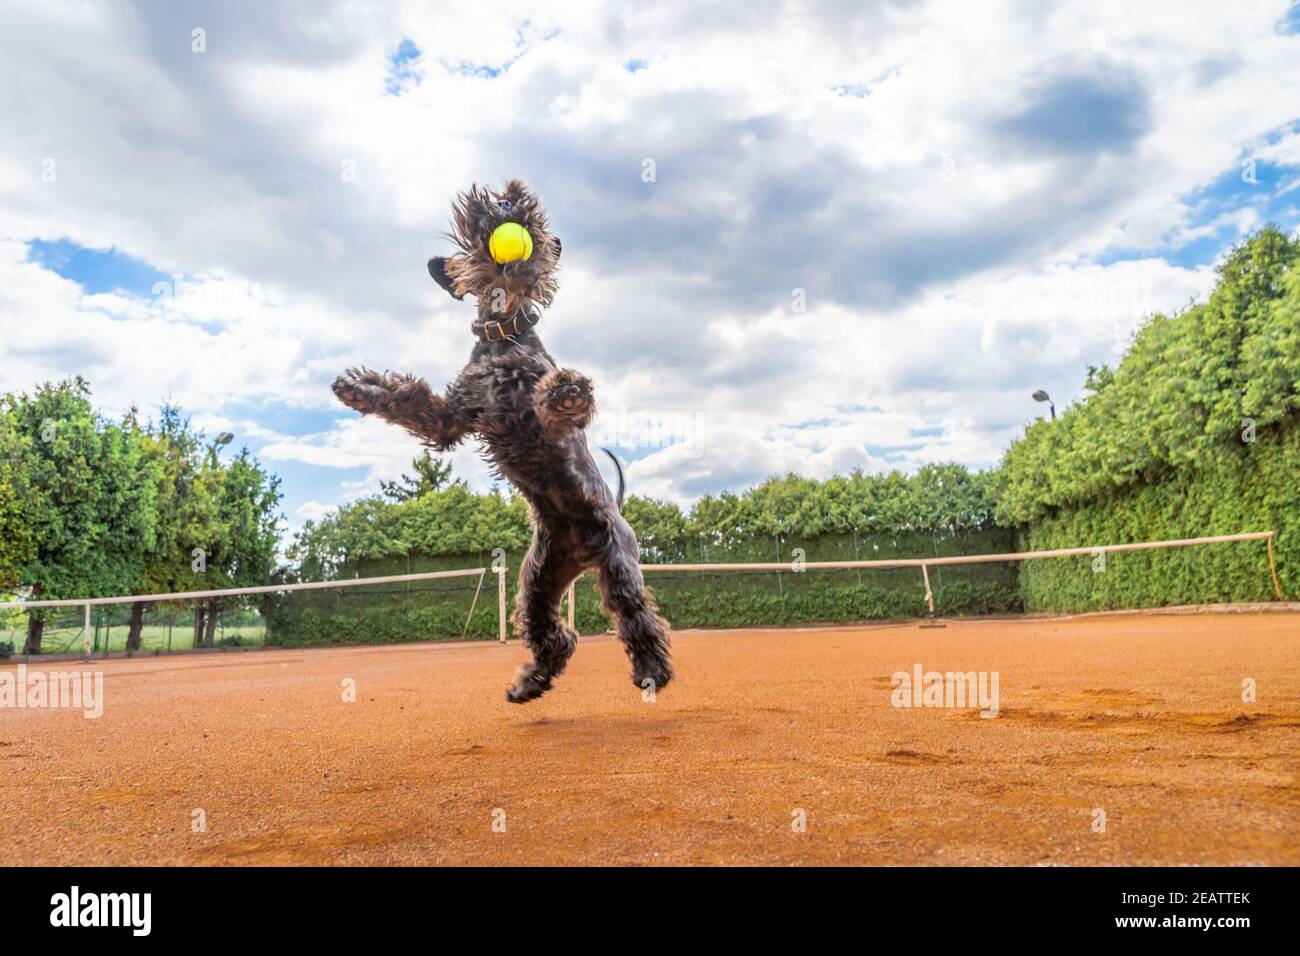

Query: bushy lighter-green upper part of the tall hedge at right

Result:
[997,228,1300,522]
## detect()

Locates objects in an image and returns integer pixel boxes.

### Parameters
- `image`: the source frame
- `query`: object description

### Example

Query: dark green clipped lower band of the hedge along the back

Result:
[267,529,1022,646]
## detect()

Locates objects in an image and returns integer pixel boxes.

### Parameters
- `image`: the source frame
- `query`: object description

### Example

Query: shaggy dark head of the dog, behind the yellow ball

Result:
[429,179,560,319]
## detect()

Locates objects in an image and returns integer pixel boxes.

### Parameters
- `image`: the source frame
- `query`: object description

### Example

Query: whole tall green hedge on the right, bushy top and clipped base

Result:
[1013,226,1300,611]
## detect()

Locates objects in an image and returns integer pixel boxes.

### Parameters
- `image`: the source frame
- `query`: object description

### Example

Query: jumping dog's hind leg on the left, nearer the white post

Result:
[506,527,581,704]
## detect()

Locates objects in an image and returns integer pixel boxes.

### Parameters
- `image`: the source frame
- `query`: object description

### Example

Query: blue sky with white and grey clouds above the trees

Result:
[0,0,1300,532]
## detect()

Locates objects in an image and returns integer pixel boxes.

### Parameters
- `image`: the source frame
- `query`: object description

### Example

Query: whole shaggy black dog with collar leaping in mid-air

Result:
[334,181,672,704]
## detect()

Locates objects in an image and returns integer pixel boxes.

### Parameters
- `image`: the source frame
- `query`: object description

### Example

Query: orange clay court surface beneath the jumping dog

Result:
[0,614,1300,865]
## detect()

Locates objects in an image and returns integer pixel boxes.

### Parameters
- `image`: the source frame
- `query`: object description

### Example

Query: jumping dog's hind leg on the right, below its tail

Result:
[599,515,672,693]
